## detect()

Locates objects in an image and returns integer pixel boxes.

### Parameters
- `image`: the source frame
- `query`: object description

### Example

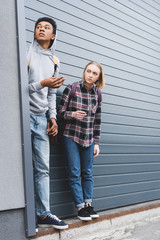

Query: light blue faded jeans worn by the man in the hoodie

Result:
[30,114,50,217]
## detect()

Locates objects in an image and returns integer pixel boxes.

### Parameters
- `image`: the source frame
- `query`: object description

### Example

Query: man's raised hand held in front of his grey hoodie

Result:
[40,76,66,88]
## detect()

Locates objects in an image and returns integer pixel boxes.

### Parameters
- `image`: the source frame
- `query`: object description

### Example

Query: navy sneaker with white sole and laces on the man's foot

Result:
[38,214,68,229]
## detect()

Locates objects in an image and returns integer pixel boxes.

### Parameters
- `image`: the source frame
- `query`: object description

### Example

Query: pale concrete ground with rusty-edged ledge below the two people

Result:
[32,200,160,240]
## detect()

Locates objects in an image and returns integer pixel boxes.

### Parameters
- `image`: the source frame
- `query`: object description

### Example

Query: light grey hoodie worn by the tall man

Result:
[28,39,60,119]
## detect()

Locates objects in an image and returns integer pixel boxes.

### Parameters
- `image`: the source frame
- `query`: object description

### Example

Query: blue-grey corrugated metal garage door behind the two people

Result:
[25,0,160,216]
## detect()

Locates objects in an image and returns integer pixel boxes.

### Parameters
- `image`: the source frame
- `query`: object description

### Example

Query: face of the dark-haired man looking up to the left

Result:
[34,21,55,42]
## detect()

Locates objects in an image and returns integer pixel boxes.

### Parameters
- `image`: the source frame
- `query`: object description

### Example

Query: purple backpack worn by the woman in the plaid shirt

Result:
[57,82,102,142]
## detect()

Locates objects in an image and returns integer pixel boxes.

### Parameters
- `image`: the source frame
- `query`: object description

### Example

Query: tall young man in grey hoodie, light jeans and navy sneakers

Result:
[27,17,68,229]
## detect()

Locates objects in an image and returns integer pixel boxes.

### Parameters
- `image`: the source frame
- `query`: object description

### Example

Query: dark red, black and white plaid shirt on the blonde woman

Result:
[58,82,101,147]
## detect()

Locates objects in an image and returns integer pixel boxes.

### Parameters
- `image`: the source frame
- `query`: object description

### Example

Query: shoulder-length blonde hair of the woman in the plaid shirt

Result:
[82,61,105,89]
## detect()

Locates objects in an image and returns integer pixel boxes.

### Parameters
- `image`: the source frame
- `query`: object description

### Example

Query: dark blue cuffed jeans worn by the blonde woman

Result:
[63,136,94,207]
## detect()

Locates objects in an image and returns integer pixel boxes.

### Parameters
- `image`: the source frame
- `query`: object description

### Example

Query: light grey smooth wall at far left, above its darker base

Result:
[0,0,25,210]
